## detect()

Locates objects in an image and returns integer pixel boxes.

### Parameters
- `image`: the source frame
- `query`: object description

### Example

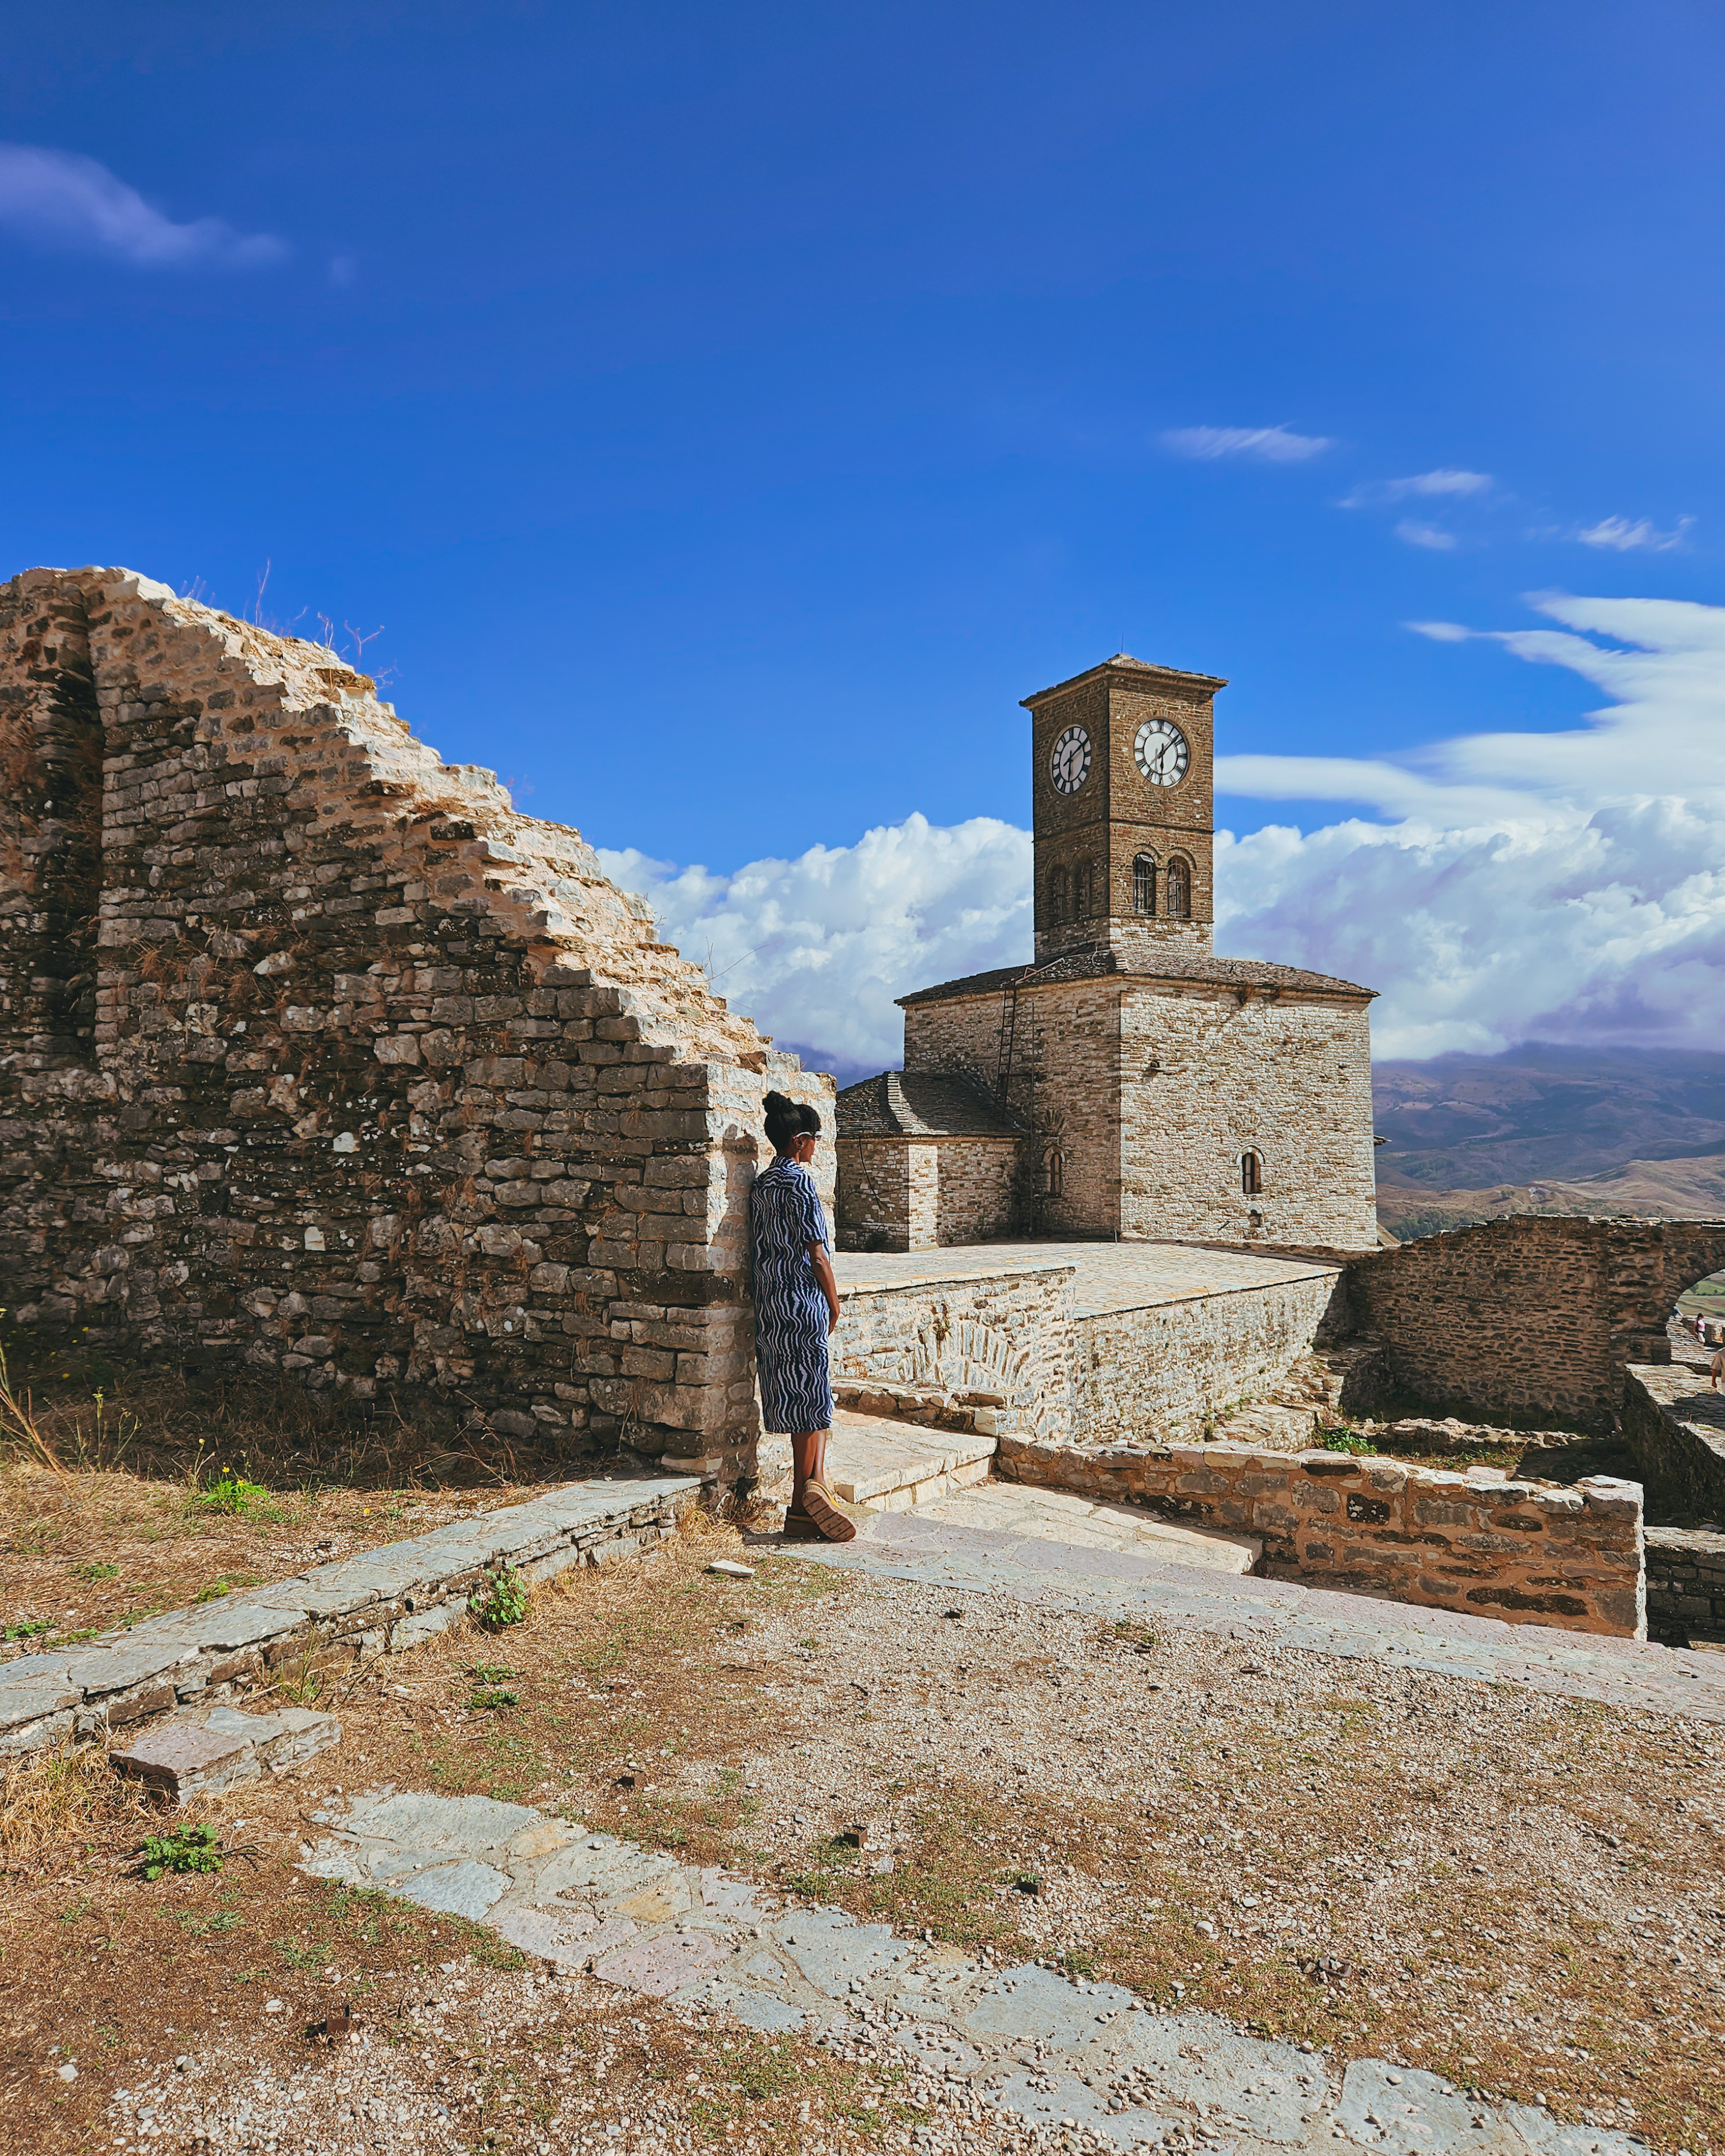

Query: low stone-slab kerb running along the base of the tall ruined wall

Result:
[0,1475,701,1753]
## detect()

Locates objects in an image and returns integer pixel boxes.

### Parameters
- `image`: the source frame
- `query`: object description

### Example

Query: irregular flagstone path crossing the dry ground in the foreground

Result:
[302,1789,1645,2156]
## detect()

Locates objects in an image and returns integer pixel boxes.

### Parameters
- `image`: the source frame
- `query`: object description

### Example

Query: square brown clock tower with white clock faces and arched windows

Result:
[1024,651,1227,973]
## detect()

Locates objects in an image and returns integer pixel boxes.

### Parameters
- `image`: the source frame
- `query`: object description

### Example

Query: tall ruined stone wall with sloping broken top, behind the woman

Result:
[0,569,832,1477]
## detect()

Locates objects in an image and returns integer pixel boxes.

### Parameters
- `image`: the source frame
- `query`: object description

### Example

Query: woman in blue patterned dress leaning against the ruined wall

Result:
[748,1093,856,1541]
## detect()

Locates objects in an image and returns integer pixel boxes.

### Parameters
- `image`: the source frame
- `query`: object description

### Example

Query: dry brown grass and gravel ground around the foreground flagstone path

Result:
[0,1524,1725,2152]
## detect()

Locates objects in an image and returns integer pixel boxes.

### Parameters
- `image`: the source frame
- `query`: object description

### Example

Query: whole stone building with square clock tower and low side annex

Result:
[839,653,1376,1248]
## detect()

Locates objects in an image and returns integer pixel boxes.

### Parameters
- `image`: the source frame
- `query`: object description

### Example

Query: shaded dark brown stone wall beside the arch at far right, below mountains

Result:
[1350,1214,1725,1430]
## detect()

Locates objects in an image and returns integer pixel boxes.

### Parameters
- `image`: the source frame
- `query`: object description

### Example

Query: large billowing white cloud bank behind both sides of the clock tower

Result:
[604,593,1725,1076]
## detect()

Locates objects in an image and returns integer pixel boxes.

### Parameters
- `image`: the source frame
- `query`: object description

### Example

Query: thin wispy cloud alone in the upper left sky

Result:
[0,142,287,270]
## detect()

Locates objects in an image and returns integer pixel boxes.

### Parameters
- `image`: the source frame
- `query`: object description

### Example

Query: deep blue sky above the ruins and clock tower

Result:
[0,0,1725,1073]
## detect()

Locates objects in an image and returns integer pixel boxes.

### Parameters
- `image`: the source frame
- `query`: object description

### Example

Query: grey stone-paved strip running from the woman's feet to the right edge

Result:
[798,1486,1725,1722]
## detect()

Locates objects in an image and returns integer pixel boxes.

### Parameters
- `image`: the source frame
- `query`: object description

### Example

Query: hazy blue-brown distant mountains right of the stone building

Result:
[1371,1041,1725,1198]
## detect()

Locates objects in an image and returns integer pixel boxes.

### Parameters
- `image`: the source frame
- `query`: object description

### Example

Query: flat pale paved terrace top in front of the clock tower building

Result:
[832,1242,1341,1317]
